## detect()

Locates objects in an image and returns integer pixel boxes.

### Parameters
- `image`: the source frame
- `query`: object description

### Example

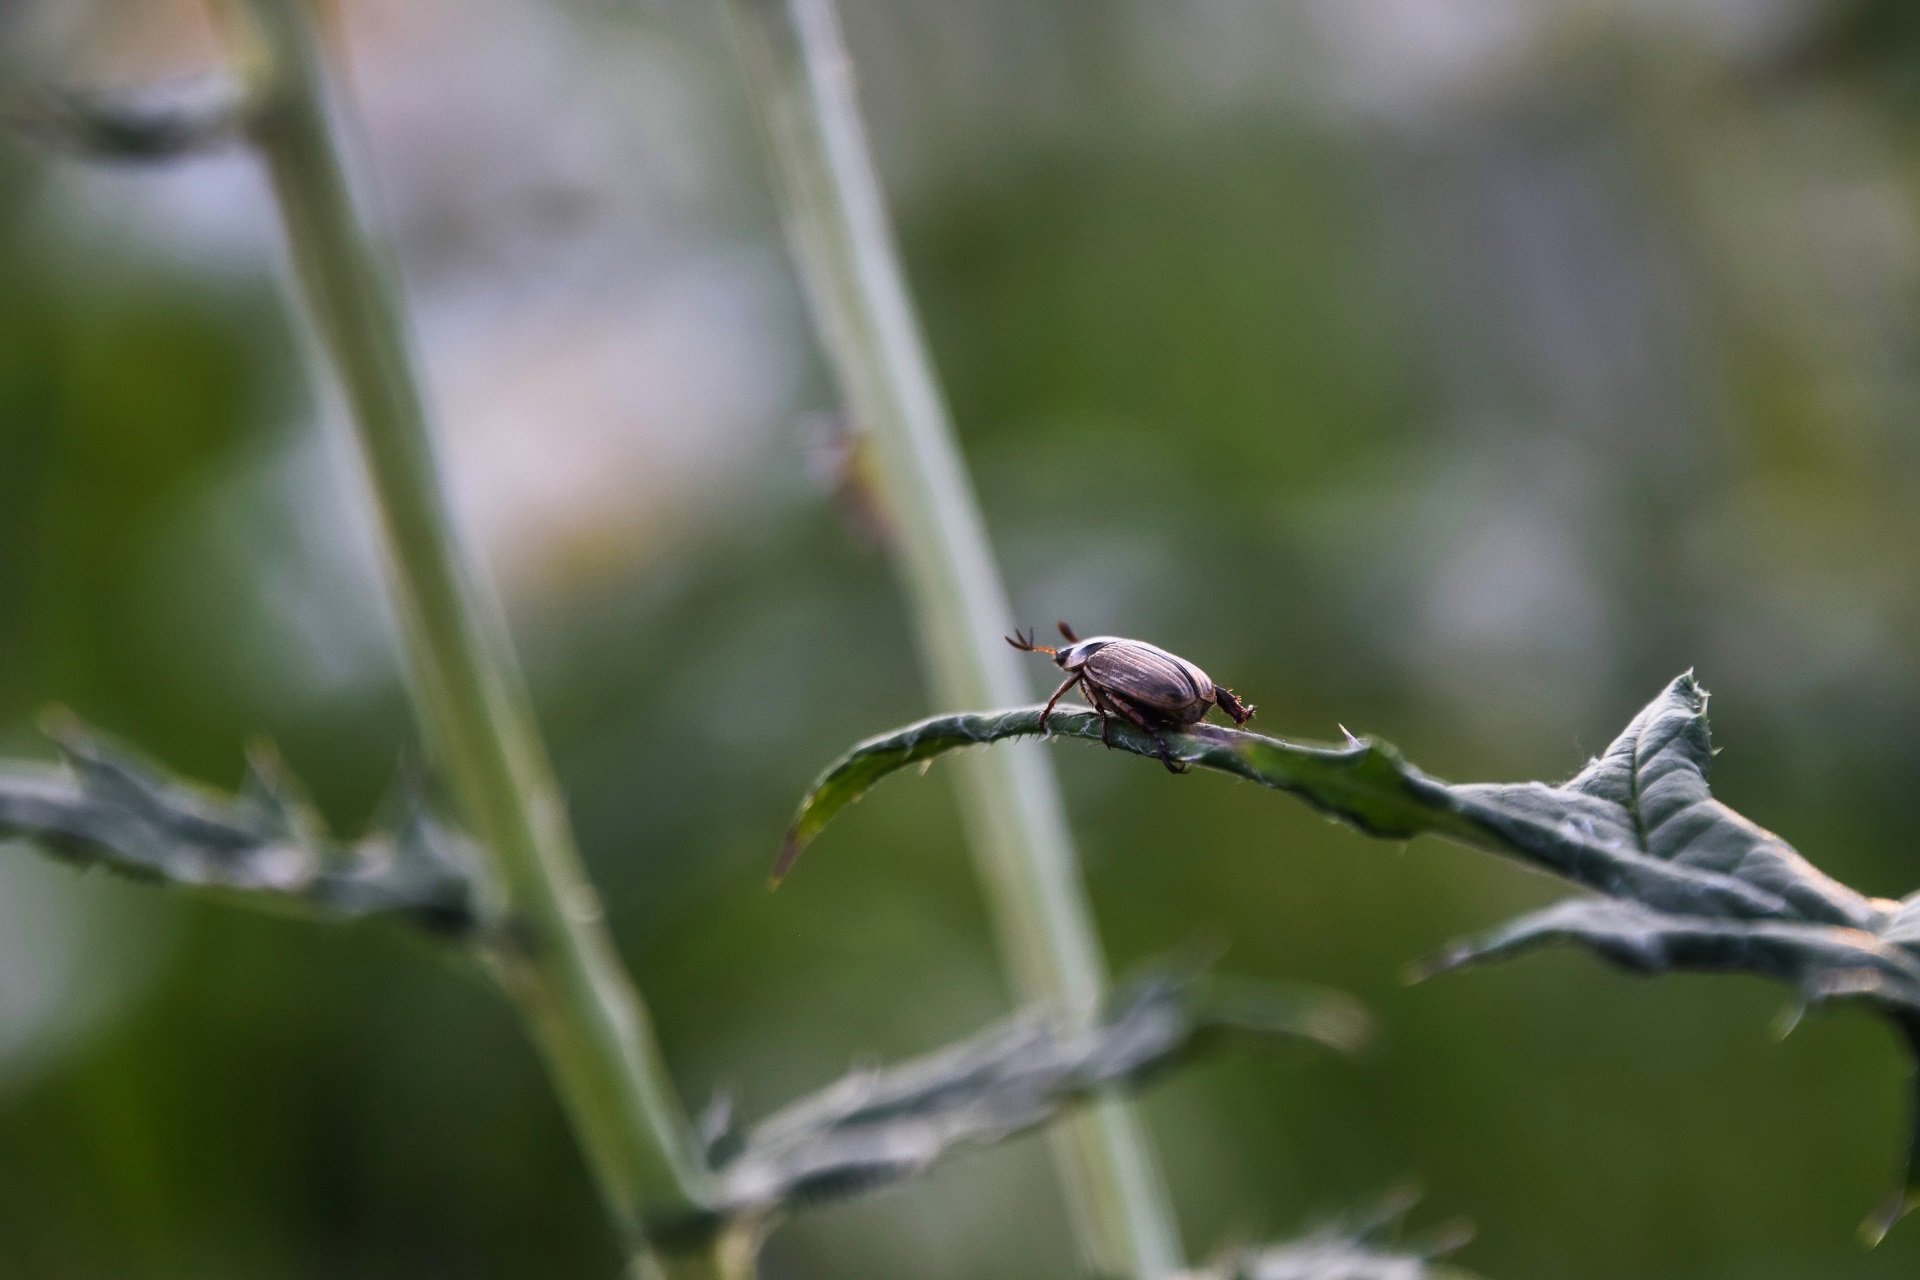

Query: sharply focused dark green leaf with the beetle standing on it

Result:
[778,674,1920,1240]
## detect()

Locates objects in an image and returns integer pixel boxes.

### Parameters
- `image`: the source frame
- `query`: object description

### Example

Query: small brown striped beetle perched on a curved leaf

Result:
[1006,622,1254,773]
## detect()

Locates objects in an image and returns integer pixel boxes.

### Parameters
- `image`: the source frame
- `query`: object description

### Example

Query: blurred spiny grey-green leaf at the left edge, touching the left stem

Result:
[0,722,478,933]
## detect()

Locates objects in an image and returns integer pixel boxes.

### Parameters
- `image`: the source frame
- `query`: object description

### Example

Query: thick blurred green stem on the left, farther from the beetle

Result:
[219,0,733,1280]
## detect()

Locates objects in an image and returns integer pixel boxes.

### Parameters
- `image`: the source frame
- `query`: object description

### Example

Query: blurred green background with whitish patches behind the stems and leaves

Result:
[0,0,1920,1280]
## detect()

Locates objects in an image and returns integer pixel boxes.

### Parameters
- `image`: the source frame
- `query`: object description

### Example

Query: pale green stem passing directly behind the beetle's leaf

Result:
[730,0,1181,1276]
